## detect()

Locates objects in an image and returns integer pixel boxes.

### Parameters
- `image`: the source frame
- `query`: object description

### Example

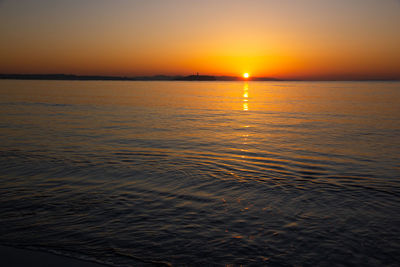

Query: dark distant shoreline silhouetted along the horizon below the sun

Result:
[0,74,400,82]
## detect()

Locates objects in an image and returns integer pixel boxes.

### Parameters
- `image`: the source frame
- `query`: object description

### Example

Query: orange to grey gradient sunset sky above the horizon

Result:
[0,0,400,79]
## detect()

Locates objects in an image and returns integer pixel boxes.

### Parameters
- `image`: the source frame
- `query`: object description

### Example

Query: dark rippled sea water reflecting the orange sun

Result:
[0,80,400,266]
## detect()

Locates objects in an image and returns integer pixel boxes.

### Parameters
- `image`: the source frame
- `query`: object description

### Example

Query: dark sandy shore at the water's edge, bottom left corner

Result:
[0,246,105,267]
